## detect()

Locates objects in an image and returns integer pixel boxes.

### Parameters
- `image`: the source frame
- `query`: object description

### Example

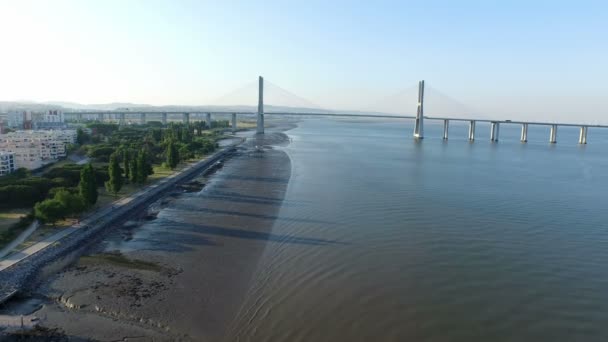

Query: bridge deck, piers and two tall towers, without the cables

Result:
[64,76,608,144]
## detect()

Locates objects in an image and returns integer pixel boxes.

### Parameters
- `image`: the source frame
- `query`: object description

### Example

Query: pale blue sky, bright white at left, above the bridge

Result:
[0,0,608,123]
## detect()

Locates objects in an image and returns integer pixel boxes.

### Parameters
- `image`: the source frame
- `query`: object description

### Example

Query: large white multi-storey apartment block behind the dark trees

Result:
[0,130,76,170]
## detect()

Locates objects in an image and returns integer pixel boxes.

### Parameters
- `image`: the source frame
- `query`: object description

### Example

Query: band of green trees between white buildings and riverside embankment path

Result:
[5,121,228,227]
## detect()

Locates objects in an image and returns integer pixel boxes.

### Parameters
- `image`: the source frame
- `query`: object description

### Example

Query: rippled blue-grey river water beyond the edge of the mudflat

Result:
[227,120,608,341]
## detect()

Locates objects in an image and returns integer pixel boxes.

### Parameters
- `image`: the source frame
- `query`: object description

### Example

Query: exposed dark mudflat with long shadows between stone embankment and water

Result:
[0,124,298,341]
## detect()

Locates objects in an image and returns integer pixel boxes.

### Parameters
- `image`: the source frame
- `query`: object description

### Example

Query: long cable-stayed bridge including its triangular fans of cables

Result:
[65,77,608,144]
